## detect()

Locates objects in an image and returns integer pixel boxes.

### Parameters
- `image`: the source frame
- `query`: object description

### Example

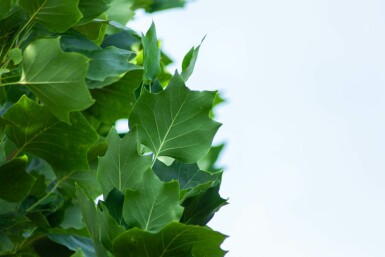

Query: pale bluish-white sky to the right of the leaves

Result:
[128,0,385,257]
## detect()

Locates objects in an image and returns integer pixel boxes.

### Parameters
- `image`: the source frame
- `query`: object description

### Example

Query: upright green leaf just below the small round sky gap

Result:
[97,128,151,196]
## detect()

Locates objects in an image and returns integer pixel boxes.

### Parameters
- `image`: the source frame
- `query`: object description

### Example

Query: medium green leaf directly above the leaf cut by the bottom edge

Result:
[123,170,183,232]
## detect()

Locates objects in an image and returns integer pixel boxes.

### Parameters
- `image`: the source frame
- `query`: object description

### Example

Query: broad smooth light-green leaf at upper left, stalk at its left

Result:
[20,38,93,122]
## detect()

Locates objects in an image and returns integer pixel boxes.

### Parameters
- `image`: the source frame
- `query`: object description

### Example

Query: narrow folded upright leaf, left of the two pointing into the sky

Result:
[142,23,161,81]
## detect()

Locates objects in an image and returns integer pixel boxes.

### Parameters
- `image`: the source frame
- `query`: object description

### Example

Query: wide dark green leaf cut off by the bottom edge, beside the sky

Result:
[113,223,226,257]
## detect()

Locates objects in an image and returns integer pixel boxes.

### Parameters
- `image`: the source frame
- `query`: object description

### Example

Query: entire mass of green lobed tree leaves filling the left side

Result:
[0,0,227,257]
